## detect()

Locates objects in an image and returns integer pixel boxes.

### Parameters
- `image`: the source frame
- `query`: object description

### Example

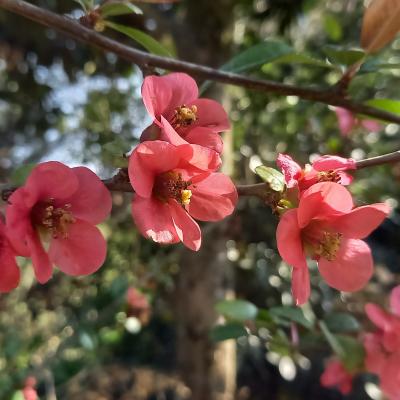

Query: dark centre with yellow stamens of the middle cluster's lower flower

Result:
[153,171,192,206]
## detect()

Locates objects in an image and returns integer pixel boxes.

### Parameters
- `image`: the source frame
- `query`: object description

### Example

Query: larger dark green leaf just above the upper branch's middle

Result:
[221,40,294,72]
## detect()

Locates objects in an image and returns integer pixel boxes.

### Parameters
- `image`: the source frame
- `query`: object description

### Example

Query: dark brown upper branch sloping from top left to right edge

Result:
[0,0,400,124]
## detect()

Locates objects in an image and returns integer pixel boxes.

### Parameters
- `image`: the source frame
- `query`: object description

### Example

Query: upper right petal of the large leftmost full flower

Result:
[64,167,112,225]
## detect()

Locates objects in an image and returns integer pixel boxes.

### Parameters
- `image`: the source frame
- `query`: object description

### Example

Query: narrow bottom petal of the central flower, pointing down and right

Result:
[168,200,201,251]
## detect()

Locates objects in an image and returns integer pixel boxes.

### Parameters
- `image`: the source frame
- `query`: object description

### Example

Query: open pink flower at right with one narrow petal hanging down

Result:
[277,182,389,305]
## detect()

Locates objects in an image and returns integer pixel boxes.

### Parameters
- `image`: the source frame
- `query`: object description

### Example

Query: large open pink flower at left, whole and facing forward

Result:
[6,161,111,283]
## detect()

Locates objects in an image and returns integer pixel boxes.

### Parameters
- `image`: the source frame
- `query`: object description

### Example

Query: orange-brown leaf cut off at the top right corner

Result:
[361,0,400,53]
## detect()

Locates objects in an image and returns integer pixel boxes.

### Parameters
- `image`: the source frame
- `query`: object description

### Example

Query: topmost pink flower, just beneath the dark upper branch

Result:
[141,73,230,153]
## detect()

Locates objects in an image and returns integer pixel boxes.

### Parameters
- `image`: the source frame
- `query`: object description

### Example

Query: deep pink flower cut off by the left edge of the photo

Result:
[0,215,20,292]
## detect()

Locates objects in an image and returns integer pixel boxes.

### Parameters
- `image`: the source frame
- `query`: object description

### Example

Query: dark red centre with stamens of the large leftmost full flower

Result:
[32,199,76,239]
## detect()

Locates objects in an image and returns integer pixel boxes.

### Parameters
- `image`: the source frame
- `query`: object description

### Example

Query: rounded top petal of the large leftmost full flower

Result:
[25,161,78,200]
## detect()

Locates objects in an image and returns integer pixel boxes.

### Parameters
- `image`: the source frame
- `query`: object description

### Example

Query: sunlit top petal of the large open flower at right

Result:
[298,182,353,228]
